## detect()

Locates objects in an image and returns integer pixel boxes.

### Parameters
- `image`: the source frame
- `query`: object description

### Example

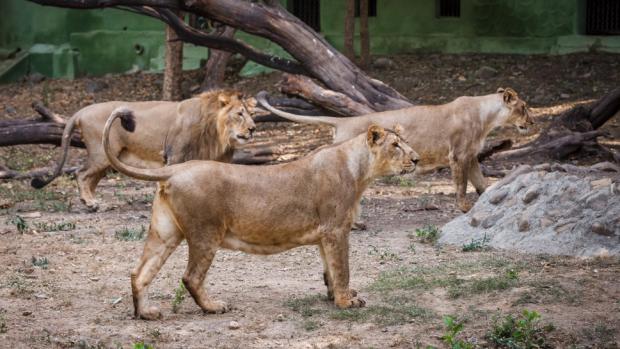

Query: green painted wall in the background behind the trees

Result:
[0,0,620,81]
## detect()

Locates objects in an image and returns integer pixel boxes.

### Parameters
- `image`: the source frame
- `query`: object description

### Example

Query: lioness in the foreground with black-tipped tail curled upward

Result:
[103,109,418,319]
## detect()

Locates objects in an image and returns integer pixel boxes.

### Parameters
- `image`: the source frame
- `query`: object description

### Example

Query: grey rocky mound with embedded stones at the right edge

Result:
[439,163,620,256]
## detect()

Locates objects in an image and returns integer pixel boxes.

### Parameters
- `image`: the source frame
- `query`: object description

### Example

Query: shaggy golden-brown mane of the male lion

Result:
[184,89,243,160]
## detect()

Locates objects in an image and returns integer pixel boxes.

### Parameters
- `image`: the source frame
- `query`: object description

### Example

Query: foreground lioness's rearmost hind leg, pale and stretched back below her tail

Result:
[131,196,183,320]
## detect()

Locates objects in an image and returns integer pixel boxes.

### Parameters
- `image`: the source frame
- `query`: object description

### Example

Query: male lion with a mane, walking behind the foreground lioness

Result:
[31,90,256,211]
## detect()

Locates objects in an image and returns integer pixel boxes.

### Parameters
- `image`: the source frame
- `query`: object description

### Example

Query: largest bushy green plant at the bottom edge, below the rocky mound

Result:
[487,309,554,349]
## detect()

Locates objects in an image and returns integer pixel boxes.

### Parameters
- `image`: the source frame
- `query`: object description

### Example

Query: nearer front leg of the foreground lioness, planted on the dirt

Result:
[320,231,366,309]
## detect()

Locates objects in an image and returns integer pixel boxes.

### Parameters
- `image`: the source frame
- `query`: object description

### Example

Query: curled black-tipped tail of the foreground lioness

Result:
[103,107,174,181]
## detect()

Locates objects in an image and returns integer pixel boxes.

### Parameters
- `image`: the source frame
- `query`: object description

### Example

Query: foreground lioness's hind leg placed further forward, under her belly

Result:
[183,229,228,314]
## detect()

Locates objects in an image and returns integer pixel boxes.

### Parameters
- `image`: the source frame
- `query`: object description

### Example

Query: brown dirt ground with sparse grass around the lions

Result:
[0,54,620,348]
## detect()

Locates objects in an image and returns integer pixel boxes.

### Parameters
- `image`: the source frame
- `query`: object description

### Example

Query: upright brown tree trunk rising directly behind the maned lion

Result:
[162,10,183,101]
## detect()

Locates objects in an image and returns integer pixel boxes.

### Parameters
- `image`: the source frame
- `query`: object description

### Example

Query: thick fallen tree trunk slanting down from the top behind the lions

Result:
[29,0,411,111]
